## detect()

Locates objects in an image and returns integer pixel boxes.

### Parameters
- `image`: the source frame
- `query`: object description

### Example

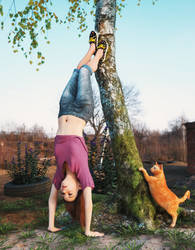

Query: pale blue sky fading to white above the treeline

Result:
[0,0,195,135]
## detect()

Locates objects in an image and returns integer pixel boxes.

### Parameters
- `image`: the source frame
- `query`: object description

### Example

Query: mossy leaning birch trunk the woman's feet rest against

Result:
[95,0,155,228]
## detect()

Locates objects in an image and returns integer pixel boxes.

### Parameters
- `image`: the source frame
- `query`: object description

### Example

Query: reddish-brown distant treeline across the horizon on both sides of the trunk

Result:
[0,119,186,168]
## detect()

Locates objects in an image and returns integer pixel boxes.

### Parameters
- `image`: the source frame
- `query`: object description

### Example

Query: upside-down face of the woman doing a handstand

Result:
[60,176,81,202]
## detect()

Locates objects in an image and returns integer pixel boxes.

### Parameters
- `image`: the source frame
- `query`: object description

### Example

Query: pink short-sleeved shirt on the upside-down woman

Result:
[53,135,94,190]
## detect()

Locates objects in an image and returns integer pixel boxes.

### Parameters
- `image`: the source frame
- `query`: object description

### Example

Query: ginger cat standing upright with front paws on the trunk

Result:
[139,162,190,227]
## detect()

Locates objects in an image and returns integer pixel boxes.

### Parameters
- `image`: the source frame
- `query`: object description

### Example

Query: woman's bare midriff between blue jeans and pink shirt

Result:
[56,115,86,136]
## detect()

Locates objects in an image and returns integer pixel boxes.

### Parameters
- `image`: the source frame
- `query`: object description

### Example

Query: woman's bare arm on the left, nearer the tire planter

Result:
[48,184,60,232]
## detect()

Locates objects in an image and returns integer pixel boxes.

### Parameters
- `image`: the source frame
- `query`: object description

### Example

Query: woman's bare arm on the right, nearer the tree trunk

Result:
[83,187,104,237]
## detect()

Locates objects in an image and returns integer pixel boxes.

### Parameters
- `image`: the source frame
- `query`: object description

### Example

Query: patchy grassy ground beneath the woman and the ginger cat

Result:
[0,188,195,250]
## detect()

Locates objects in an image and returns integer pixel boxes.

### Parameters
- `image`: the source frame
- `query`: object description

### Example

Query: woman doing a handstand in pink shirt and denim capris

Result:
[48,31,108,237]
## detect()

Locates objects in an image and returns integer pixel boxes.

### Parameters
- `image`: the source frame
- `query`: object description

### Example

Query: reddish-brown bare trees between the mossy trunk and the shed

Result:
[133,115,187,161]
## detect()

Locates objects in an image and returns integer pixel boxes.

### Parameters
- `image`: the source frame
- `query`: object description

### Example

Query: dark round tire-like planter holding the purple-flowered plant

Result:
[4,177,51,197]
